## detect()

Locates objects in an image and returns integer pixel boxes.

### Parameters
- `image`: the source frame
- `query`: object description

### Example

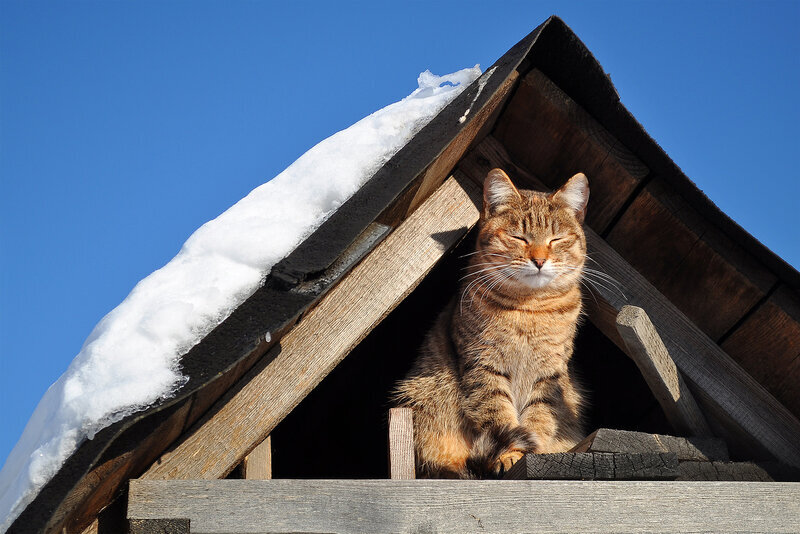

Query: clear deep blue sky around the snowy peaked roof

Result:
[0,0,800,468]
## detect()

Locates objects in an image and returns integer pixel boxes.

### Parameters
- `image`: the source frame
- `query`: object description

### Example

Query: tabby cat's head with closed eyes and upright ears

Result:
[478,169,589,290]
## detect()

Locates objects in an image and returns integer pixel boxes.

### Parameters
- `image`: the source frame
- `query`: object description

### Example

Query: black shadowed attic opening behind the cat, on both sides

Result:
[272,231,671,479]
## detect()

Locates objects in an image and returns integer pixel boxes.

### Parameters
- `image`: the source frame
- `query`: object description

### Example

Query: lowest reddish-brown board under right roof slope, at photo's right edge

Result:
[722,285,800,416]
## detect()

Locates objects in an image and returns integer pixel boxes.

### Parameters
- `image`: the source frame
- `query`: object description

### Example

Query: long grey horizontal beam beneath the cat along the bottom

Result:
[128,480,800,534]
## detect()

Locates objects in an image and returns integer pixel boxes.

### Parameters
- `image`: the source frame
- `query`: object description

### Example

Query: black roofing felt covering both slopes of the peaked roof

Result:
[9,17,800,533]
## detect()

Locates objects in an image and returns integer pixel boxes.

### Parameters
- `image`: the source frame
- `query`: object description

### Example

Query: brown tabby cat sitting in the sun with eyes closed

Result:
[394,169,589,478]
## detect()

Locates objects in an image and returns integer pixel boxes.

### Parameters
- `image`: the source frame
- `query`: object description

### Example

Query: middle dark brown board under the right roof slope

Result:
[608,176,776,340]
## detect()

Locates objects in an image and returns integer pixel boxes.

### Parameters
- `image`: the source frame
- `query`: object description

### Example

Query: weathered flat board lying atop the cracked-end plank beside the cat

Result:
[572,428,728,462]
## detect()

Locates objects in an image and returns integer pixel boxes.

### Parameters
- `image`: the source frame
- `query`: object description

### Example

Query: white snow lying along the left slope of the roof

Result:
[0,65,480,532]
